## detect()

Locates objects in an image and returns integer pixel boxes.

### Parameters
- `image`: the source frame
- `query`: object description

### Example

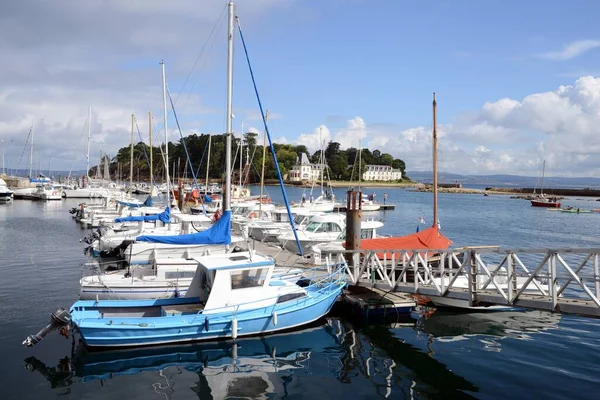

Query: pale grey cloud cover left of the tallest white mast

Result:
[0,0,293,169]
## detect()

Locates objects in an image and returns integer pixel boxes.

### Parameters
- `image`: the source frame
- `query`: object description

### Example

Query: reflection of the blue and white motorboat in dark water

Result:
[25,325,328,399]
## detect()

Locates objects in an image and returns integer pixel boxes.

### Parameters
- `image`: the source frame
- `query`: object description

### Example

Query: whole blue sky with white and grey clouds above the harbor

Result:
[0,0,600,177]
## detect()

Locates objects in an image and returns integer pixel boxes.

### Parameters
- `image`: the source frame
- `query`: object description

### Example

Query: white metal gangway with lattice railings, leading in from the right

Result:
[321,246,600,317]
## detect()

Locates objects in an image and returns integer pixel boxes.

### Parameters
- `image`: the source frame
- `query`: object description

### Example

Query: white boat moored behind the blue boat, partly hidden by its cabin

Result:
[79,253,305,300]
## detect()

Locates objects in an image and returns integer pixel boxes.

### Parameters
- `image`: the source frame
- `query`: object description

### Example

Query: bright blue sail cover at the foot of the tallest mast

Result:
[135,210,231,244]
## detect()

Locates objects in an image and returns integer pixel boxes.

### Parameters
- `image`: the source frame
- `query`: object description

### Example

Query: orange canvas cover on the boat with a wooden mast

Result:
[360,227,452,258]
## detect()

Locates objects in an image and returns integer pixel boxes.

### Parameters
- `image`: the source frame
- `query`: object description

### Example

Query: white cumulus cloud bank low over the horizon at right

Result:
[296,76,600,176]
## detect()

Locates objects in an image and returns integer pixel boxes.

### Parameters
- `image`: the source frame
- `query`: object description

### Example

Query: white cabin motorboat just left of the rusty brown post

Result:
[277,213,346,254]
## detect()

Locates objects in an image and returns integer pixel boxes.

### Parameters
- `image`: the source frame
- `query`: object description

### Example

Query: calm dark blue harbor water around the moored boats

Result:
[0,187,600,399]
